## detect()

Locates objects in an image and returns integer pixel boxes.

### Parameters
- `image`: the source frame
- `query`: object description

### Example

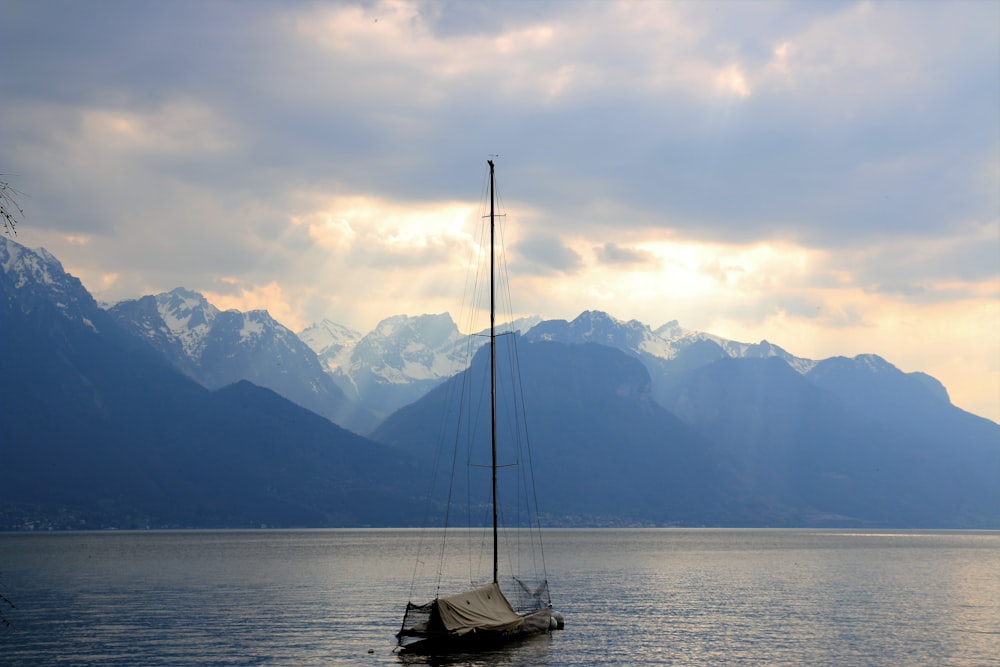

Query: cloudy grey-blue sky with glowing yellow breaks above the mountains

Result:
[0,0,1000,420]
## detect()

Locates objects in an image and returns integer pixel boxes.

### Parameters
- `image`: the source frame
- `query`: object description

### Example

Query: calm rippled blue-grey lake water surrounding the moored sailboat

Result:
[0,529,1000,667]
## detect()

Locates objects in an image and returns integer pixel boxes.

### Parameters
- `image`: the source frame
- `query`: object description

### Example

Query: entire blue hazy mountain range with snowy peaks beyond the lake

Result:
[0,237,1000,529]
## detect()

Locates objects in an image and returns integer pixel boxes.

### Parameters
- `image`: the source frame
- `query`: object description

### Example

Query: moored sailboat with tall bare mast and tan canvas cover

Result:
[396,159,563,654]
